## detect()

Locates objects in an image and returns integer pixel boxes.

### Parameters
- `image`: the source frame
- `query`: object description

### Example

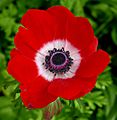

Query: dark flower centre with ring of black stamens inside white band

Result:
[43,48,73,75]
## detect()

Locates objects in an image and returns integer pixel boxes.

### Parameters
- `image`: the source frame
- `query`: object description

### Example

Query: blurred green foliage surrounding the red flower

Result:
[0,0,117,120]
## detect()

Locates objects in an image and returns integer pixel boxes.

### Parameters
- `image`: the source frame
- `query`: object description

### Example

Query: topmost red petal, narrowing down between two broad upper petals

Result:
[47,6,74,39]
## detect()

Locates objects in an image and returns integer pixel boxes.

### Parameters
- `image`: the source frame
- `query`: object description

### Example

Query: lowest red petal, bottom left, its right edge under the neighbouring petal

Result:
[20,77,57,109]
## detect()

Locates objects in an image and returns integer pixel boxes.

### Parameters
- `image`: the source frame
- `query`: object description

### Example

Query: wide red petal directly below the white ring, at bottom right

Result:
[48,77,96,100]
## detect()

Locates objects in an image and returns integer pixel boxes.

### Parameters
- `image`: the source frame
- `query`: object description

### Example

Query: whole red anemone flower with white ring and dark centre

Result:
[8,6,109,108]
